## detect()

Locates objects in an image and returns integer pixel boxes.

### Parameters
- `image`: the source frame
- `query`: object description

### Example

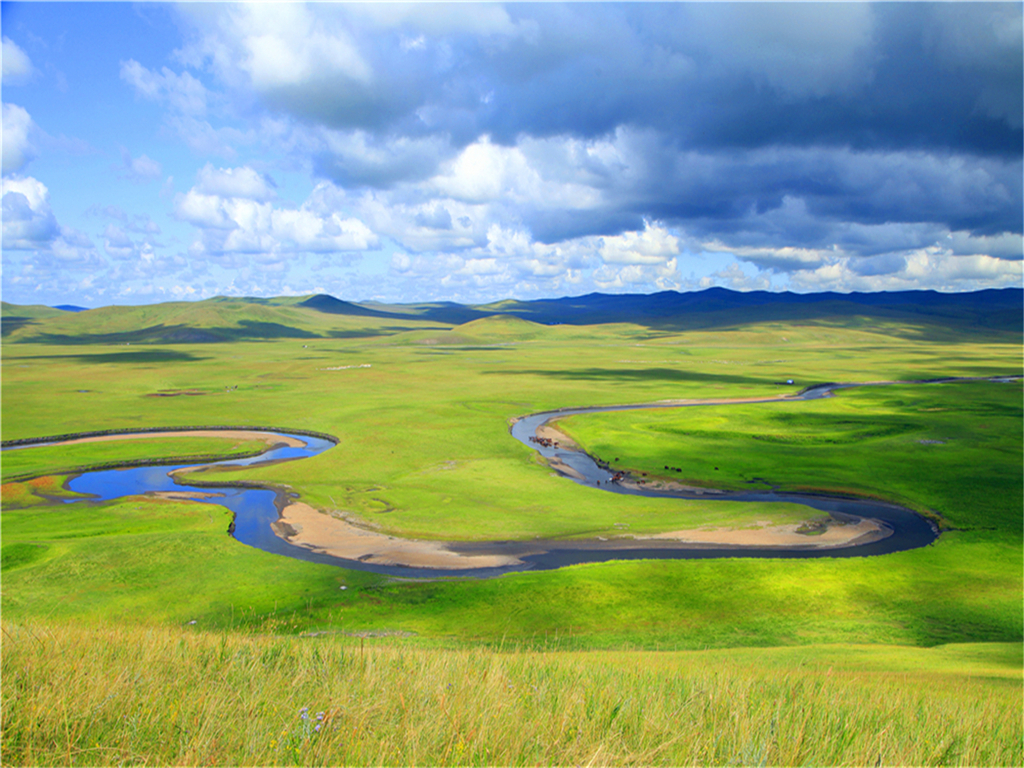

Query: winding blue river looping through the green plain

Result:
[4,377,1020,578]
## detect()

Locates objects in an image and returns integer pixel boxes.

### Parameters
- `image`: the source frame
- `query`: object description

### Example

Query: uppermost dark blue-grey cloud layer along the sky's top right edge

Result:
[199,3,1024,156]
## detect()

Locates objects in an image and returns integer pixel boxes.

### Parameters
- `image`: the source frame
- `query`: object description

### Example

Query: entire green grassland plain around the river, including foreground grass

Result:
[0,292,1024,765]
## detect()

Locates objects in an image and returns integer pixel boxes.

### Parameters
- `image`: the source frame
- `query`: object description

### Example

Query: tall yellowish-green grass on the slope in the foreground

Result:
[0,623,1024,765]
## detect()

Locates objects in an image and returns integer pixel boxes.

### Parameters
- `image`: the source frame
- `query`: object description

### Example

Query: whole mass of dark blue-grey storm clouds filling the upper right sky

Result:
[180,3,1024,274]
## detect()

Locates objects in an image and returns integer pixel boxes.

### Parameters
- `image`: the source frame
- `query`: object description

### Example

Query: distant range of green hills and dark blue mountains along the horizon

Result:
[2,288,1024,344]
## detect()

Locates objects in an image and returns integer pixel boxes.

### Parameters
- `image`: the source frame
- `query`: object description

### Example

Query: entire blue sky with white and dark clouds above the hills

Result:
[0,2,1024,307]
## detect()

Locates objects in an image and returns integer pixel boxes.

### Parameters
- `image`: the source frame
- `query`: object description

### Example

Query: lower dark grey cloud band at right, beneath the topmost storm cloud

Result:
[524,134,1022,246]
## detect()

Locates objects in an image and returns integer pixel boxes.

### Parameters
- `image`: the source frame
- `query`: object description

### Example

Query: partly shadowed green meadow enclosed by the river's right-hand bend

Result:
[560,381,1024,541]
